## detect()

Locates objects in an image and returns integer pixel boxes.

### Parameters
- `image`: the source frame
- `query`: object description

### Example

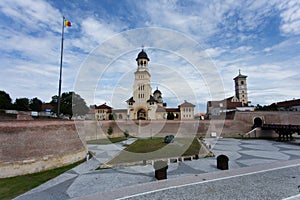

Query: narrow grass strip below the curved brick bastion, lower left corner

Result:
[0,161,83,199]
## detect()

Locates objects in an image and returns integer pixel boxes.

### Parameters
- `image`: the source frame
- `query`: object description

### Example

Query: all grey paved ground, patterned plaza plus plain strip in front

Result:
[17,138,300,200]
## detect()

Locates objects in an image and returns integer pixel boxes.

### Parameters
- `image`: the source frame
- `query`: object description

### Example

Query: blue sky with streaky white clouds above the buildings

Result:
[0,0,300,111]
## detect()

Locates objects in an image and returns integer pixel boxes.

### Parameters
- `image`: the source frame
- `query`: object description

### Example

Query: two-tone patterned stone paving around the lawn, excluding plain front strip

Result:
[16,138,300,200]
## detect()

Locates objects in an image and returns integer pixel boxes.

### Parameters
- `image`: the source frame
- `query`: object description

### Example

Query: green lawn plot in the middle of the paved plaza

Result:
[107,138,201,164]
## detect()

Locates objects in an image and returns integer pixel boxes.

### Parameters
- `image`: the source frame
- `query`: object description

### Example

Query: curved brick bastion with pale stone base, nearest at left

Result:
[0,121,86,178]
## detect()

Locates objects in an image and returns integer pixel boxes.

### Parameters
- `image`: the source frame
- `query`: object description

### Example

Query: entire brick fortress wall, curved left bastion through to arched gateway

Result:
[0,112,300,178]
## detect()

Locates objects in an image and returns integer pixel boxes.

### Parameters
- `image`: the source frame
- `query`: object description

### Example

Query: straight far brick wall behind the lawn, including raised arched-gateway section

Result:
[84,111,300,140]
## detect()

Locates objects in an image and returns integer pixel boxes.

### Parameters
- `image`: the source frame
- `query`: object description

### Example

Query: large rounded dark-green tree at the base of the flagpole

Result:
[50,92,89,119]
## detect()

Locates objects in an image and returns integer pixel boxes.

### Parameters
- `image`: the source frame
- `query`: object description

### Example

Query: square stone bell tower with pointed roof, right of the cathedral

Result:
[233,70,248,106]
